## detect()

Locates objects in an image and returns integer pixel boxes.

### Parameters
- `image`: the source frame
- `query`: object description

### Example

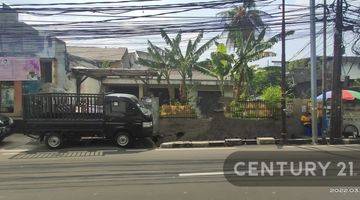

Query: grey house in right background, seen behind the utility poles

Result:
[286,56,360,98]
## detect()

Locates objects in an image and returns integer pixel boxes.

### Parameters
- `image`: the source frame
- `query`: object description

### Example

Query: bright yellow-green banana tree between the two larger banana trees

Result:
[196,44,234,96]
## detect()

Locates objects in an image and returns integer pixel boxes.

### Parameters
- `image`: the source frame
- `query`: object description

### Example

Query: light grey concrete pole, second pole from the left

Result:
[310,0,317,144]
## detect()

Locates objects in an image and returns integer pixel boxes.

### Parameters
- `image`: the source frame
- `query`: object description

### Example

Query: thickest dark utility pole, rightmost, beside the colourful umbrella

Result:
[330,0,343,144]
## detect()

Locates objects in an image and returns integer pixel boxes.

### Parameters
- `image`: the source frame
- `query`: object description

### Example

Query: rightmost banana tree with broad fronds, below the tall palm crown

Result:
[231,29,294,100]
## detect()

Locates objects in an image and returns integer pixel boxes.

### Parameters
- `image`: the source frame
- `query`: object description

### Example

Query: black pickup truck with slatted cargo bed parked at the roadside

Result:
[23,93,153,149]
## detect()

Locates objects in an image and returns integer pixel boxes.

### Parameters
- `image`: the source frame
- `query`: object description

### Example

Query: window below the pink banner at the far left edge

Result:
[0,81,15,113]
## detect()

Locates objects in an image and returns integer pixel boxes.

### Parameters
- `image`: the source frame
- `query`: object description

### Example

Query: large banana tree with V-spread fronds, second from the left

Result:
[161,30,218,102]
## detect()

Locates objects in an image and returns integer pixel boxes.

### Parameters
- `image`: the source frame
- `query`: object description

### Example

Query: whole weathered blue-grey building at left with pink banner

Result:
[0,4,68,118]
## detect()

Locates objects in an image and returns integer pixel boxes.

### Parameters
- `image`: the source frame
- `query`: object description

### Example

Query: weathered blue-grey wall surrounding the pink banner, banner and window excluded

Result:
[0,6,66,118]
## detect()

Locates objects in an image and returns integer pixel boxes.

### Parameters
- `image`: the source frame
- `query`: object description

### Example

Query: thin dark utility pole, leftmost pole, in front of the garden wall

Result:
[281,0,287,144]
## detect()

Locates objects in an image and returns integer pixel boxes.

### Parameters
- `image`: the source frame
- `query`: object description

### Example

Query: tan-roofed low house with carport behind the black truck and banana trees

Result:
[68,47,233,116]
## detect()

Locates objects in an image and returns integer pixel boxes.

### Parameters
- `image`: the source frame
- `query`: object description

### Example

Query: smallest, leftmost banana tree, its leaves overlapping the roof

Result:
[137,41,175,104]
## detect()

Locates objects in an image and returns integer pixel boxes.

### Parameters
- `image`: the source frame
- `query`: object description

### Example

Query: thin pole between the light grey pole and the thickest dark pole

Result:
[321,0,327,144]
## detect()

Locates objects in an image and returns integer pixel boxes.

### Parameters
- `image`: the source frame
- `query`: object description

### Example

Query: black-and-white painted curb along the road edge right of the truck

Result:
[160,137,360,149]
